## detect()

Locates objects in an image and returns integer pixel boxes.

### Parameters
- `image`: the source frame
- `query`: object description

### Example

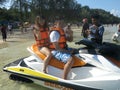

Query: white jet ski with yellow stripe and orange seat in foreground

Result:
[3,43,120,90]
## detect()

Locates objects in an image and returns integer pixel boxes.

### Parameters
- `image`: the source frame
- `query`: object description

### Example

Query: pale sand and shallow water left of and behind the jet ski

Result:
[0,26,117,90]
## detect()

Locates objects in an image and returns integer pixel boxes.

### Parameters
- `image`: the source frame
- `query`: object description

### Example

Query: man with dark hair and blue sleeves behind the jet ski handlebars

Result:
[75,14,104,48]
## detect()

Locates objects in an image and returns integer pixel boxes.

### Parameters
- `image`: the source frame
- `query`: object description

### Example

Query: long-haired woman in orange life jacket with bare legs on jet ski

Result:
[33,16,52,73]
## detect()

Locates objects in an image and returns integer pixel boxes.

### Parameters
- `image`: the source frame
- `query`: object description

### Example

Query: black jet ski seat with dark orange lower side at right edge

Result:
[99,42,120,67]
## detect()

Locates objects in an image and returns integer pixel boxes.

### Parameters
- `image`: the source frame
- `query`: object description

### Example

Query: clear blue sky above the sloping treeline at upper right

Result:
[76,0,120,17]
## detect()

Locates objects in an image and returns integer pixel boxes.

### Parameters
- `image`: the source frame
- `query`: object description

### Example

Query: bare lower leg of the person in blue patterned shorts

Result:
[63,57,74,79]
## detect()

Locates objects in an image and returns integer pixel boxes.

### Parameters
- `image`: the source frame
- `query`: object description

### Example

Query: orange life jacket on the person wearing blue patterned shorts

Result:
[49,27,67,49]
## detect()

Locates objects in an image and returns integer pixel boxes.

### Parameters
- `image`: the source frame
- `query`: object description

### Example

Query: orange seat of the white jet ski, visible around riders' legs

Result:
[31,44,86,69]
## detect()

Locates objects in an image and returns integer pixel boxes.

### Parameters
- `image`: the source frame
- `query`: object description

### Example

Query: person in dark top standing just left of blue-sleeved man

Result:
[81,18,89,38]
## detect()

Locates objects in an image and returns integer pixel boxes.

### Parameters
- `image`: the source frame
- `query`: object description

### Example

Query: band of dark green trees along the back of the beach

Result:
[0,0,120,24]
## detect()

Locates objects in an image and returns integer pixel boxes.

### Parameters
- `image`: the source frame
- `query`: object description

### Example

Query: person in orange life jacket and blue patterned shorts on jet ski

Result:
[50,20,74,79]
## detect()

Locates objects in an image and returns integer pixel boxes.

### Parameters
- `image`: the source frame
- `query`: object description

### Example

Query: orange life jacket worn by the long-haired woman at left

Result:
[34,28,50,47]
